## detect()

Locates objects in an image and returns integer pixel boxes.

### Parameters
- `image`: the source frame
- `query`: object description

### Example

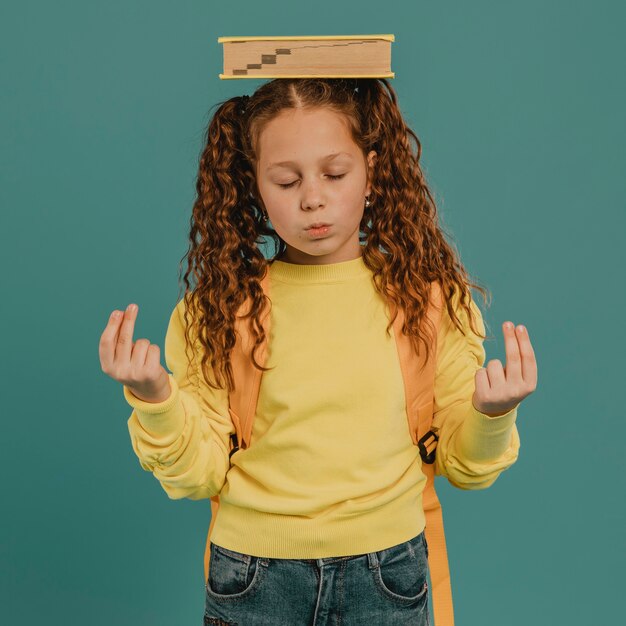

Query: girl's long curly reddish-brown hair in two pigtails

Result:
[173,78,487,391]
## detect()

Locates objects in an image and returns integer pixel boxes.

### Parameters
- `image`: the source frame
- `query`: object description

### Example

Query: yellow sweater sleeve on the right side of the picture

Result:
[433,292,520,490]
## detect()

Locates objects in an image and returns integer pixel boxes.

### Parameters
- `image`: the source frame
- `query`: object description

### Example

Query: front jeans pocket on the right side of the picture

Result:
[373,533,428,604]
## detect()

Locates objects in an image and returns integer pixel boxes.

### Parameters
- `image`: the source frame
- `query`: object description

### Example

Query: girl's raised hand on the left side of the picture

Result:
[99,304,171,402]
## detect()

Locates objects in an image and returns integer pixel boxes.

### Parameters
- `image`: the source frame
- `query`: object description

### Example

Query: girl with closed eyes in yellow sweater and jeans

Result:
[100,78,537,626]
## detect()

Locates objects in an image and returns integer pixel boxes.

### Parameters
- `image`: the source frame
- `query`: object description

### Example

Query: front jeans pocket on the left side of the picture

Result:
[206,543,263,600]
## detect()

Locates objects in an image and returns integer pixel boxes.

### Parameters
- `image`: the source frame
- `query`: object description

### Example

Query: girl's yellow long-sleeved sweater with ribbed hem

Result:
[124,257,520,559]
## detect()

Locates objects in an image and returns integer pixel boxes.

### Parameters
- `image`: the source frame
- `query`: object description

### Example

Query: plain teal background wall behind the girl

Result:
[0,0,626,626]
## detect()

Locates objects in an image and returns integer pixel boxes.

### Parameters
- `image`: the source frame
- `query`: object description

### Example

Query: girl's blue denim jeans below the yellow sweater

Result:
[204,532,431,626]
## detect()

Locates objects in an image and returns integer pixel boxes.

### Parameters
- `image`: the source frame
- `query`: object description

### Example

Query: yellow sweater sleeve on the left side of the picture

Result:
[123,299,235,500]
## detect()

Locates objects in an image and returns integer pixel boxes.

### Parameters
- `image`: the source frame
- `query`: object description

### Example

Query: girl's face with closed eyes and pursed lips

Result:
[257,109,376,265]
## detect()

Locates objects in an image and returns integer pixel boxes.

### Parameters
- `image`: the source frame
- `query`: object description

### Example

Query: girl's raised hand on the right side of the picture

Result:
[472,322,537,417]
